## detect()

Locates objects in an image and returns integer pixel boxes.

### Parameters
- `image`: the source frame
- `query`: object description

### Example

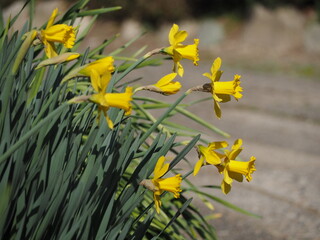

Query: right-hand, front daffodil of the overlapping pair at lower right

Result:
[216,139,256,194]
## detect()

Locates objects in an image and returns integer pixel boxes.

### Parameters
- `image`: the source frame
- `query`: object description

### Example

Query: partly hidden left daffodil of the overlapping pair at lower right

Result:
[193,141,228,176]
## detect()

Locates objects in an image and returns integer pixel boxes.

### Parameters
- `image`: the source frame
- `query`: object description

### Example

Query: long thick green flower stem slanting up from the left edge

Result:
[0,103,69,165]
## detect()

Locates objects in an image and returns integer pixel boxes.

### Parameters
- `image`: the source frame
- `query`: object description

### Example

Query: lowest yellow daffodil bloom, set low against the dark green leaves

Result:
[140,156,182,213]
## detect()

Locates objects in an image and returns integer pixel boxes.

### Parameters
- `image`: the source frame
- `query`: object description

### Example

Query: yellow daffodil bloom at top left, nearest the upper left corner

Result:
[39,8,76,58]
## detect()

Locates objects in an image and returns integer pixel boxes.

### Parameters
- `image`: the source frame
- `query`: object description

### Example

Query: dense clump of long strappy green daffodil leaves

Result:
[0,0,256,239]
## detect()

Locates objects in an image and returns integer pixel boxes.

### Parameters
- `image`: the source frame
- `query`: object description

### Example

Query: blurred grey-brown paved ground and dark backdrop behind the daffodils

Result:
[1,0,320,240]
